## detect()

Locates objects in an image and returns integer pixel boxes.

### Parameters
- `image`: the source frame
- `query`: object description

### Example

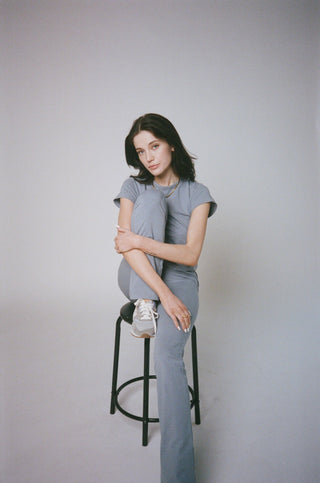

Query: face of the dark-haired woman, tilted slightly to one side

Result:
[133,131,174,178]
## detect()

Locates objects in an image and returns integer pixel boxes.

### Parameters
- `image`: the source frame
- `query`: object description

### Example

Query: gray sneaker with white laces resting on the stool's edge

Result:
[130,299,158,337]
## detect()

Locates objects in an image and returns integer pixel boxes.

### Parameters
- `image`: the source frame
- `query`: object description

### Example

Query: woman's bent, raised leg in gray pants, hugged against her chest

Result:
[118,189,167,300]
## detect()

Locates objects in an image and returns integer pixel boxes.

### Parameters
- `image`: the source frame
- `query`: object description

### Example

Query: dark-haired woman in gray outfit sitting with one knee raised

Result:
[114,114,217,483]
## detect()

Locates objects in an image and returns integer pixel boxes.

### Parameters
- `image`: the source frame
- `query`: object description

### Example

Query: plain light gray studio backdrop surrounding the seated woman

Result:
[0,0,320,483]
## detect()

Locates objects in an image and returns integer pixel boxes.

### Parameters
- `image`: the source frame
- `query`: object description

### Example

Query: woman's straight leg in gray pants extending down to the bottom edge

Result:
[154,280,198,483]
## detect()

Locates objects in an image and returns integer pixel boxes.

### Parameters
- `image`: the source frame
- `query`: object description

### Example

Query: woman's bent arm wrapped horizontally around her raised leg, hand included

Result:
[116,200,210,267]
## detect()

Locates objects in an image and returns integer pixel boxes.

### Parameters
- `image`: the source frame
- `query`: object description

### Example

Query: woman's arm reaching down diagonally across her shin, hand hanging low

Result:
[115,198,190,330]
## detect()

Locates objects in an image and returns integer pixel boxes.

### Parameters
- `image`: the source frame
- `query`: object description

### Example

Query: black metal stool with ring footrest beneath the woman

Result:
[110,302,200,446]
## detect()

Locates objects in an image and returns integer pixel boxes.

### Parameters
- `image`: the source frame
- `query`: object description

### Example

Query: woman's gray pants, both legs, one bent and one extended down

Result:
[118,190,198,483]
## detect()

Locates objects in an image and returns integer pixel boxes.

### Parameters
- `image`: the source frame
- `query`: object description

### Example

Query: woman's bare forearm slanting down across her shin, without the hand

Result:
[123,250,170,299]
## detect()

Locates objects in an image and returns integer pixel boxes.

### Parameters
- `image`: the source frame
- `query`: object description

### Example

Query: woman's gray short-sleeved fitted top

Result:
[113,177,217,270]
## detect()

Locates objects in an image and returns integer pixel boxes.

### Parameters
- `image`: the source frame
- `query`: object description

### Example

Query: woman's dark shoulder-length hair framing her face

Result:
[125,113,196,184]
